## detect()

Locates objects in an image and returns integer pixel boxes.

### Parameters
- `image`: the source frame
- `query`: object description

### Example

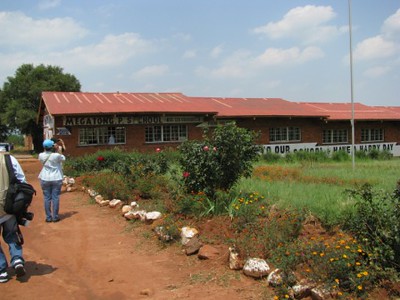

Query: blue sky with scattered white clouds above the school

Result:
[0,0,400,106]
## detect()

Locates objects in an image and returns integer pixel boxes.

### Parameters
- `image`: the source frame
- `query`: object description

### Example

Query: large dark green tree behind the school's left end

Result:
[0,64,81,152]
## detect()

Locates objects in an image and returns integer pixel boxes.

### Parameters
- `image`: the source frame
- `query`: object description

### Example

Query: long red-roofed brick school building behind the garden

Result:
[38,92,400,156]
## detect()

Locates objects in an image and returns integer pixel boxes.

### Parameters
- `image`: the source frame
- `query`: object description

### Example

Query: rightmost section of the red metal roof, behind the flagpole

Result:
[301,102,400,120]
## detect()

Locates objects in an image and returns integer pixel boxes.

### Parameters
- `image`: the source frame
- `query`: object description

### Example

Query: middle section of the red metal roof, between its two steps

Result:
[192,97,329,117]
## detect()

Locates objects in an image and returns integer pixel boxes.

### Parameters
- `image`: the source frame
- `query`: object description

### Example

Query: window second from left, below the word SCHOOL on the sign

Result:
[145,125,187,143]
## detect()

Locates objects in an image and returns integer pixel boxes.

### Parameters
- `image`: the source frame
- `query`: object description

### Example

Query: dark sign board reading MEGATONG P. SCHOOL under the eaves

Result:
[63,115,203,126]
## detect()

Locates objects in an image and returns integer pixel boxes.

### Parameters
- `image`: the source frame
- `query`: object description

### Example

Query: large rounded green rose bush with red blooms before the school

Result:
[179,123,261,198]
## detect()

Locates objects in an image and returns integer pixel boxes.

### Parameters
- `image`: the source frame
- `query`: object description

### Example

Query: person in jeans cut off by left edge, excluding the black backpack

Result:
[0,153,26,283]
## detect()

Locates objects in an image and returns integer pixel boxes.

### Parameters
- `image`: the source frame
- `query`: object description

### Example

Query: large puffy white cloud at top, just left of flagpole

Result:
[253,5,343,44]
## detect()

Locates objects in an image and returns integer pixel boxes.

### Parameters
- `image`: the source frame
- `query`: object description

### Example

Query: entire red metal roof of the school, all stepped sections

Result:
[42,92,400,120]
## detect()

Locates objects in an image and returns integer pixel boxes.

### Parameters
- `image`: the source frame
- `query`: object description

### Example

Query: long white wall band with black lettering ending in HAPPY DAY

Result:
[263,143,400,156]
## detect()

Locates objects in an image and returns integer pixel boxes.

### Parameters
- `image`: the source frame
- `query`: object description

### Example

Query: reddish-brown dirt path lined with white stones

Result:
[0,158,270,300]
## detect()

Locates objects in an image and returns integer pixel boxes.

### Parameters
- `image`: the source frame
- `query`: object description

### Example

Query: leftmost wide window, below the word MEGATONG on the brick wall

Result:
[79,127,126,146]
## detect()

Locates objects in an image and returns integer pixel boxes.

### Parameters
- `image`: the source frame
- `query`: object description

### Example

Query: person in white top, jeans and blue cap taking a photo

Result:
[38,140,65,222]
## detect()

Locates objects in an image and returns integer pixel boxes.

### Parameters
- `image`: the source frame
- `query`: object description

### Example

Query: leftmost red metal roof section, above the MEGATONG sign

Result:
[42,92,216,115]
